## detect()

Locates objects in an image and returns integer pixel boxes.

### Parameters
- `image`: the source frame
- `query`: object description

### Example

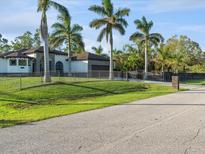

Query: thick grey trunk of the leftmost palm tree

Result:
[41,14,51,83]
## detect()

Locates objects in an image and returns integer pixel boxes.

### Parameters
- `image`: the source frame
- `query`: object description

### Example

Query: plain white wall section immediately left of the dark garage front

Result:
[71,61,88,73]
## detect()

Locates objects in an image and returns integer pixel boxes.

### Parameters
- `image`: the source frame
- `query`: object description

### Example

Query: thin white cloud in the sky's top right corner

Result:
[144,0,205,13]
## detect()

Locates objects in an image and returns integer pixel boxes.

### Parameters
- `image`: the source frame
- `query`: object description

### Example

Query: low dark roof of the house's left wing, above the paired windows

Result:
[0,49,32,59]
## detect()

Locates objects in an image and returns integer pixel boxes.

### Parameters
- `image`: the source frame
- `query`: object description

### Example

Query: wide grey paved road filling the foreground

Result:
[0,88,205,154]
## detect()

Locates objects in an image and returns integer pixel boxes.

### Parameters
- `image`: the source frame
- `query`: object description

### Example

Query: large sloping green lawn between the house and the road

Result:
[0,78,178,127]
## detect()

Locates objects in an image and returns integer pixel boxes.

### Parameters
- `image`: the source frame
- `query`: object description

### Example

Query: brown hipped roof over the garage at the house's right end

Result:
[72,52,109,61]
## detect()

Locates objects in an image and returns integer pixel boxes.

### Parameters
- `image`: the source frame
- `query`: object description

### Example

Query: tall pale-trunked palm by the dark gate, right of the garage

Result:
[130,17,164,79]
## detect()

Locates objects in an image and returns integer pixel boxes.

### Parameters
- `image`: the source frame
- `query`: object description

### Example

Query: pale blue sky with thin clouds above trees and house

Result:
[0,0,205,51]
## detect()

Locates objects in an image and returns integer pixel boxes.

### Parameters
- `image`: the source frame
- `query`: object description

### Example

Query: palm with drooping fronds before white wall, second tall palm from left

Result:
[51,10,84,74]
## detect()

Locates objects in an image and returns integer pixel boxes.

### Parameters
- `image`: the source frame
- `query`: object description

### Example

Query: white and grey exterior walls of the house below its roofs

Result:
[0,52,109,73]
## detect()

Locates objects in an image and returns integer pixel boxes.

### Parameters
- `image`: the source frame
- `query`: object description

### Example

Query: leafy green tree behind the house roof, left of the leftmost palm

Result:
[11,31,33,50]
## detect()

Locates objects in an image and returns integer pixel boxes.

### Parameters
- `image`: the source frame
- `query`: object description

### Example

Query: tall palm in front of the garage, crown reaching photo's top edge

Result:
[89,0,130,80]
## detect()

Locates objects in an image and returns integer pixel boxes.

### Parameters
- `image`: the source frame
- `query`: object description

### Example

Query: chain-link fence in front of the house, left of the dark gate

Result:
[0,71,131,94]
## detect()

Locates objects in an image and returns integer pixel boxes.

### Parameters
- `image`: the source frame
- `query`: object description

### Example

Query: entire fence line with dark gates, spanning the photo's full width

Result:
[0,71,205,94]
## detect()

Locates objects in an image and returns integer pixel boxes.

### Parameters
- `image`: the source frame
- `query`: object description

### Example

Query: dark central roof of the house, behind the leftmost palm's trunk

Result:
[23,46,68,56]
